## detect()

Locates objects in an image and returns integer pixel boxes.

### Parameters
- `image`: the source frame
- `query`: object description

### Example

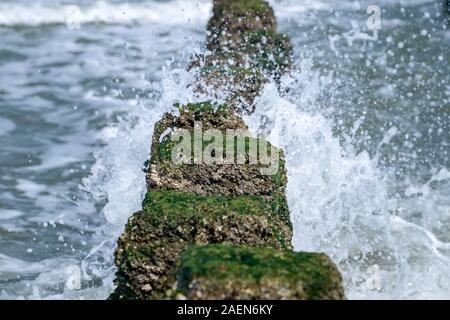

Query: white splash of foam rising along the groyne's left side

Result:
[82,64,194,226]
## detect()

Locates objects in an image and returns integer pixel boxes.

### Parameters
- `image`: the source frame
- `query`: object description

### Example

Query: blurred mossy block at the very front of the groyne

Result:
[172,244,345,300]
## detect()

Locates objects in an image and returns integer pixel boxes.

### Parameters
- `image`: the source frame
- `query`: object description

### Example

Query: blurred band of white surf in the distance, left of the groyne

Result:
[0,0,211,27]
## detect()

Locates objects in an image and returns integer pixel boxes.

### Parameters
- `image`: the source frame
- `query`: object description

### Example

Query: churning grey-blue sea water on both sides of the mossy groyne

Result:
[0,0,450,299]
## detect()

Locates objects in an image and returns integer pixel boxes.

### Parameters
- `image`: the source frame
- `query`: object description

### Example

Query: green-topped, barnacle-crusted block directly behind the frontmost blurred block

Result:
[112,191,292,299]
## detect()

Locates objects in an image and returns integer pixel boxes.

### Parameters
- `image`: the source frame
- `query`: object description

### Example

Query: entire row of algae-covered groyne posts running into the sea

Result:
[111,0,345,299]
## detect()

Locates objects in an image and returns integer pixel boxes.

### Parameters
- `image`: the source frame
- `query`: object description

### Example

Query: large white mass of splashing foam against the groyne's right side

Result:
[248,60,450,299]
